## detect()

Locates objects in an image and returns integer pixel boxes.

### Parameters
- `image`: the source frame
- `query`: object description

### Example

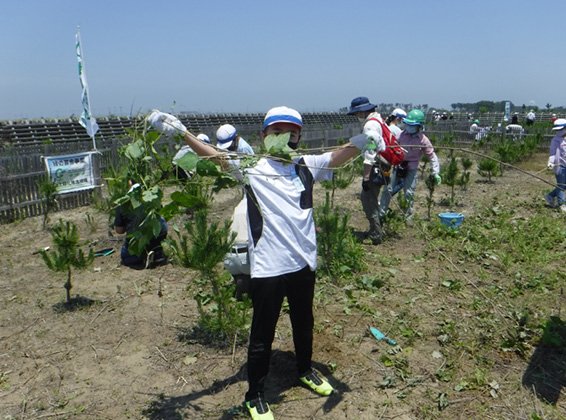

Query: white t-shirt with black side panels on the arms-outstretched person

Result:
[244,152,332,278]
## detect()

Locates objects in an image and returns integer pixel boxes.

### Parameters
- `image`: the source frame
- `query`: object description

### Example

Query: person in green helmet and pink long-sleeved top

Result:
[379,109,442,225]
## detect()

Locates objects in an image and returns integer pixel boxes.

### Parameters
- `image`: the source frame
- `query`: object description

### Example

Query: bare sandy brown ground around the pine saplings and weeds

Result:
[0,155,566,419]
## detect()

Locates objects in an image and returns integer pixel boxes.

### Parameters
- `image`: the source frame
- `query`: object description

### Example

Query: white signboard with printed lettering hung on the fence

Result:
[44,152,95,194]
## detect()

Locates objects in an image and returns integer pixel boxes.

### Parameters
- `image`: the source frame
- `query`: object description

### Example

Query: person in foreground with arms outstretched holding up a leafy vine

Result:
[147,106,385,419]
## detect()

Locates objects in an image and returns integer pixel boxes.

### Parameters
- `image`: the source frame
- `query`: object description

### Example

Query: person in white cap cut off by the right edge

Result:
[544,118,566,211]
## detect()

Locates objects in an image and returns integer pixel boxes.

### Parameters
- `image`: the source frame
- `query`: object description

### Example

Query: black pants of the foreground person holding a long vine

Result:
[246,266,315,401]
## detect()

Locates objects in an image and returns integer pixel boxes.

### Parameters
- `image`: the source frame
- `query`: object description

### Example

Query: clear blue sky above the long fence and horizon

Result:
[0,0,566,120]
